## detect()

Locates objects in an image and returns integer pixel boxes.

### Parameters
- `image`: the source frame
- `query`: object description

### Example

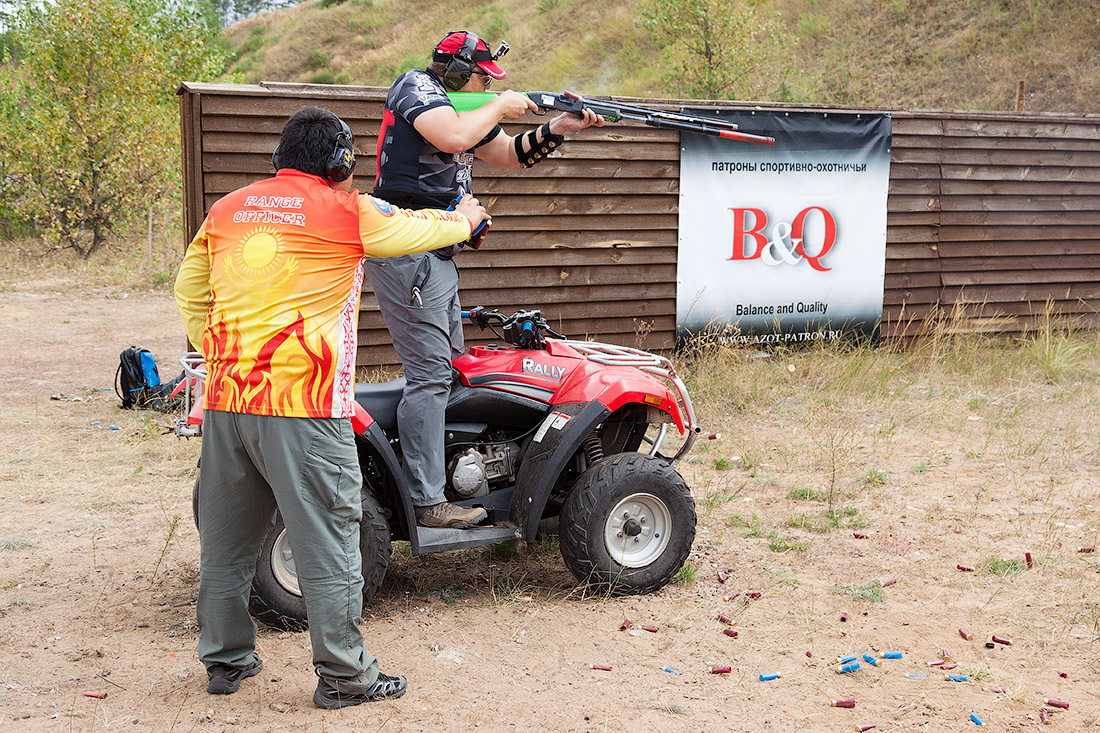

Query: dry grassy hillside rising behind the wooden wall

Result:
[226,0,1100,112]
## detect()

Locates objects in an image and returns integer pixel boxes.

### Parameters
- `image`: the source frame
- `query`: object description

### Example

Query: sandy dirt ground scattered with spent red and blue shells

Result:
[0,277,1100,731]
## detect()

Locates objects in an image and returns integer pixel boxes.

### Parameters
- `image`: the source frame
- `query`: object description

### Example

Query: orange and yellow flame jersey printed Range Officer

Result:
[176,168,471,417]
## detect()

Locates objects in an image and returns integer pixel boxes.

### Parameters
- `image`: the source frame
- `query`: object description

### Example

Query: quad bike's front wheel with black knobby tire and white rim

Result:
[559,453,695,593]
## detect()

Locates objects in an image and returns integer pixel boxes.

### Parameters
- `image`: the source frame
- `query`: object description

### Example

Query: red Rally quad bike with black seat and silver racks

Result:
[175,308,700,628]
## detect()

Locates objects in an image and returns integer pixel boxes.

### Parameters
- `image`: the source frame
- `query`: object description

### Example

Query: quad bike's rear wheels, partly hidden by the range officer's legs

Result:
[191,481,392,631]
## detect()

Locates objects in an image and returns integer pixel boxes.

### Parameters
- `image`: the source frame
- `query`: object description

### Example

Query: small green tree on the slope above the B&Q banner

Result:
[639,0,798,99]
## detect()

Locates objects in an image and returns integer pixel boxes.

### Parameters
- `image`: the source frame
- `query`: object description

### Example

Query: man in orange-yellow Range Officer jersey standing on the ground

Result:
[176,107,487,709]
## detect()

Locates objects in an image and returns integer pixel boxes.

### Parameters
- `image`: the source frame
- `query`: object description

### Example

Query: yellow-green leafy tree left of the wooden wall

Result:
[0,0,226,259]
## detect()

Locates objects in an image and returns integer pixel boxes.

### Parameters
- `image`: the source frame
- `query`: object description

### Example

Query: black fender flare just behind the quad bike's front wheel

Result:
[509,402,611,543]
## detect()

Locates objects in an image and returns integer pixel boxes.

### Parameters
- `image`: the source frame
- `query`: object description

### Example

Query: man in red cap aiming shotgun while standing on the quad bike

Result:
[366,31,604,528]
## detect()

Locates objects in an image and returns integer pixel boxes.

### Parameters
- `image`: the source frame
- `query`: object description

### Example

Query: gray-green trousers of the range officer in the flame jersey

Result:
[191,409,378,693]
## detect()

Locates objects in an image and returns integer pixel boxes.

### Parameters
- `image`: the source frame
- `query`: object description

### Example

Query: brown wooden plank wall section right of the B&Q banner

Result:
[883,112,1100,335]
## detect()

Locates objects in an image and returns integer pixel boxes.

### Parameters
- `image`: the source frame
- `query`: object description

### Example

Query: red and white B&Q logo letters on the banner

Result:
[729,206,836,272]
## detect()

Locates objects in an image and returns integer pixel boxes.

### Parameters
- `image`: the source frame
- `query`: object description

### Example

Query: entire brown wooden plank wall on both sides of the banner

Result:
[180,83,1100,365]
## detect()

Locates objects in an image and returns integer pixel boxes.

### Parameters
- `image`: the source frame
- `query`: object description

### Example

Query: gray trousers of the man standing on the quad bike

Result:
[366,252,463,506]
